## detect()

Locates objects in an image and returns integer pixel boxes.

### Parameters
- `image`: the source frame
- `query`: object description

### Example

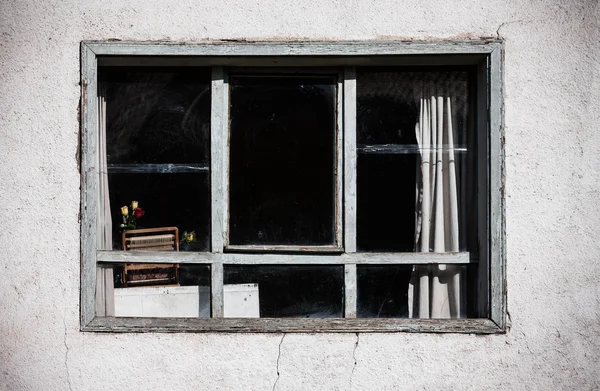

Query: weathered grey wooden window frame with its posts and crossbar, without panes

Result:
[80,41,506,334]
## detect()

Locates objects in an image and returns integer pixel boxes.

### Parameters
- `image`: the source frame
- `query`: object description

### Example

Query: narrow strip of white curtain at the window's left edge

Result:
[96,88,115,316]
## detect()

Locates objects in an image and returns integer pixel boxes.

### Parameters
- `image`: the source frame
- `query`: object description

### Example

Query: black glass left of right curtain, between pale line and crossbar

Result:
[357,155,417,251]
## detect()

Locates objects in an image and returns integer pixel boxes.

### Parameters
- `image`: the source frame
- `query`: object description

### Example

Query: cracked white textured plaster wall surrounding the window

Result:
[0,0,600,390]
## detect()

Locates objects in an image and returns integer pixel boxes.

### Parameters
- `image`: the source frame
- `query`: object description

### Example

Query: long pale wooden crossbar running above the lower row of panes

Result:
[98,251,477,265]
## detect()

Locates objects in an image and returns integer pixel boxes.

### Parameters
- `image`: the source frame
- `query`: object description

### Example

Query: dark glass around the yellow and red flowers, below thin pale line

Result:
[109,172,210,251]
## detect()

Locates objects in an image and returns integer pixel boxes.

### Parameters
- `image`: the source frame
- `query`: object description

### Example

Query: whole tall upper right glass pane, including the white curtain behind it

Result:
[357,68,477,252]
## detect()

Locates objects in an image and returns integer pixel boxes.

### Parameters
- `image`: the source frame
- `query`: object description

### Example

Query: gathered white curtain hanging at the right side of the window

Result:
[409,82,466,318]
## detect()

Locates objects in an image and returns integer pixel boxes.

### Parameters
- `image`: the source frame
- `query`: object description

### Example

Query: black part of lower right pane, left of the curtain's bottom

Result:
[356,265,413,318]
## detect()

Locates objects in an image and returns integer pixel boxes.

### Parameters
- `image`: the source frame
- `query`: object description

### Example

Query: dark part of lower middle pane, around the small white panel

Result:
[224,265,344,318]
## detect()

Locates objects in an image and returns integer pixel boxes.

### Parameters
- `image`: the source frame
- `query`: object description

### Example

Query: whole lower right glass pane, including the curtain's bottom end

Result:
[356,264,477,318]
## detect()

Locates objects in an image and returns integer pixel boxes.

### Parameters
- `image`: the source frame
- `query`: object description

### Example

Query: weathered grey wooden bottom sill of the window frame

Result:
[83,317,503,334]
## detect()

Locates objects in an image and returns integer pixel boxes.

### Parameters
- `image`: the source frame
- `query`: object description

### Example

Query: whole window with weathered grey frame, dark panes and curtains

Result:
[81,42,505,333]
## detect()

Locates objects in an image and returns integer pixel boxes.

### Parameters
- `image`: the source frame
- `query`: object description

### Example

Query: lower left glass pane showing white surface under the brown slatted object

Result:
[106,264,210,318]
